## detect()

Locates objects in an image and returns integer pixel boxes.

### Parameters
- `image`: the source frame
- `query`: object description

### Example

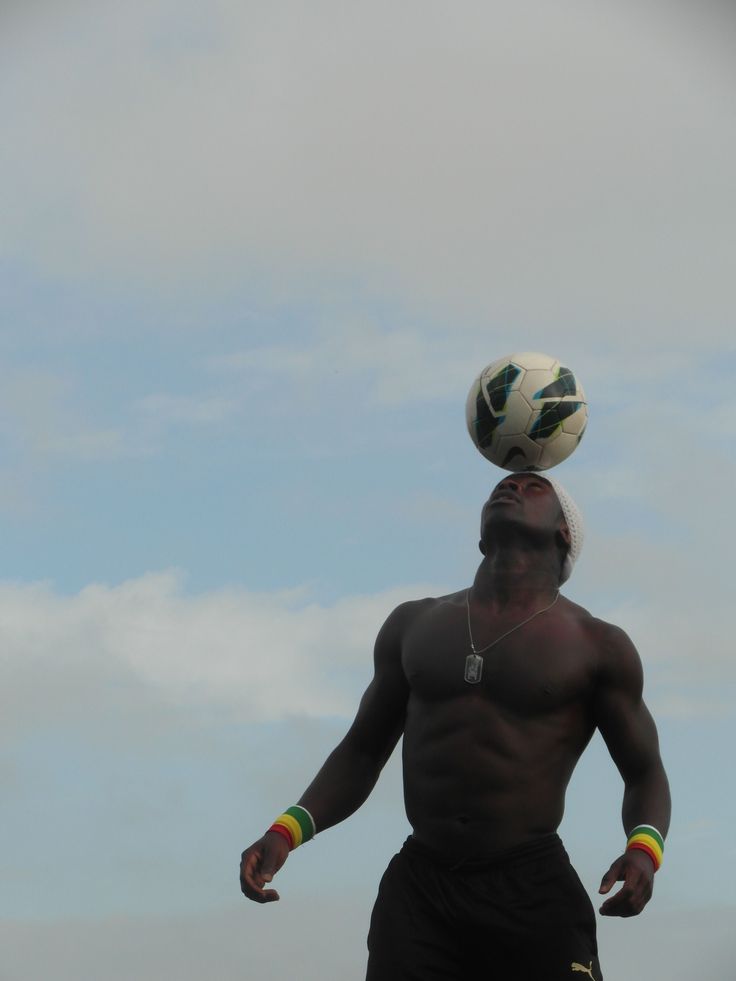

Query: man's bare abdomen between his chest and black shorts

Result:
[403,695,591,858]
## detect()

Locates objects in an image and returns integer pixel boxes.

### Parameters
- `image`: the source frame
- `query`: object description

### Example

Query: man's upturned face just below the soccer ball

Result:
[481,473,567,540]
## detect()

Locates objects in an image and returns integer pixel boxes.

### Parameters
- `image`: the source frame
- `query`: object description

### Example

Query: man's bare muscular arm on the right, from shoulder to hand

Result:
[594,622,671,916]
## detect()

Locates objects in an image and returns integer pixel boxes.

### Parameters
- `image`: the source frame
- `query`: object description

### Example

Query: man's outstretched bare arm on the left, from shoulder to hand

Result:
[240,602,418,903]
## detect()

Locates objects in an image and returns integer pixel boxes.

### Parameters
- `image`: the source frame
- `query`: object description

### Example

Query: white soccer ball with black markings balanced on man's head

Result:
[465,352,588,470]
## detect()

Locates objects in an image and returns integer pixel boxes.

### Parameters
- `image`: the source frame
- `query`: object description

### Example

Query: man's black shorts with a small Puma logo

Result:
[366,834,602,981]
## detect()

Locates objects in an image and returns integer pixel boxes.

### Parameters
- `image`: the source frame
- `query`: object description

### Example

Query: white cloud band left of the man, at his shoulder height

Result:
[0,573,442,728]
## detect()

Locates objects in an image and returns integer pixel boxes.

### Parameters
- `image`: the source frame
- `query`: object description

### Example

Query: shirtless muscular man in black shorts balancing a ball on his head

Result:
[241,473,670,981]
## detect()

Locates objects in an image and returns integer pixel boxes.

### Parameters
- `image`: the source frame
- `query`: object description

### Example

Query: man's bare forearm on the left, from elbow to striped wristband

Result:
[299,737,398,831]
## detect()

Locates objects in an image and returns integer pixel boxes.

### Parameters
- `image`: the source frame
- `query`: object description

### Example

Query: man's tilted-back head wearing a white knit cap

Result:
[480,472,583,583]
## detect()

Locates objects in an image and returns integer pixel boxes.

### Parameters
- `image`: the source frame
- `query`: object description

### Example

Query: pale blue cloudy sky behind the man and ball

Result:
[0,0,736,981]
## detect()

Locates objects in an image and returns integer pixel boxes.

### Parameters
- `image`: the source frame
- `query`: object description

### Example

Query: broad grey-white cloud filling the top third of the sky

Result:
[3,0,736,338]
